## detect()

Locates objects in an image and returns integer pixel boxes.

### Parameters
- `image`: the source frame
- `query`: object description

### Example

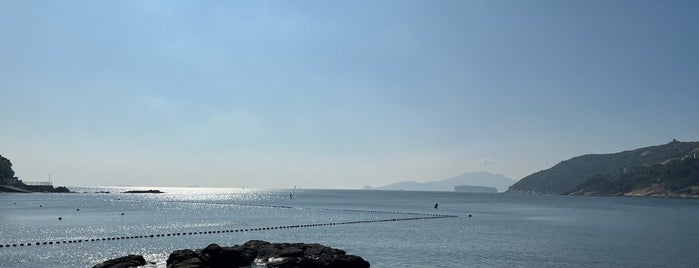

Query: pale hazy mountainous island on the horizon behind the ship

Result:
[371,172,515,192]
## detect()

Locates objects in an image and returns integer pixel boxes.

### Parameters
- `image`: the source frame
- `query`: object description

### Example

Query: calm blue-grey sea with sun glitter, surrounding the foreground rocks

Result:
[0,187,699,267]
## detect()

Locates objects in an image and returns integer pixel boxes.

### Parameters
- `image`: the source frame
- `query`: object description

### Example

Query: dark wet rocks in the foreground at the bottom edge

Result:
[93,240,370,268]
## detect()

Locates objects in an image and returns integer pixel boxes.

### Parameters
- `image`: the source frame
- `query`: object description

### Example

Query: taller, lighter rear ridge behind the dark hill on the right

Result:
[507,140,699,194]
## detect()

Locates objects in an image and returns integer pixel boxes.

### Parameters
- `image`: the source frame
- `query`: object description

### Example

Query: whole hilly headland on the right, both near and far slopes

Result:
[507,140,699,197]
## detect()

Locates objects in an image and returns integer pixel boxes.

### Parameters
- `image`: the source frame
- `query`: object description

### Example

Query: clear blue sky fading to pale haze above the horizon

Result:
[0,0,699,189]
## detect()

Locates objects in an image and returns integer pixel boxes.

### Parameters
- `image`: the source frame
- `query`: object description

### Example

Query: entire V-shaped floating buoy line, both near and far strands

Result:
[0,201,460,248]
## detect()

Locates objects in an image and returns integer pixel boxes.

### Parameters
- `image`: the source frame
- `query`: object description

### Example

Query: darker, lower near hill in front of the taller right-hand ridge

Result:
[569,155,699,197]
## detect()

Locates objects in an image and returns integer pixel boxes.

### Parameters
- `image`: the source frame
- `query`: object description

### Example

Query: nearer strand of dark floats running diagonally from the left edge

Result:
[0,215,457,248]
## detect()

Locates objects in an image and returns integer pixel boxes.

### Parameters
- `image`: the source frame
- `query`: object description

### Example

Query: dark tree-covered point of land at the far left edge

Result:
[0,155,70,193]
